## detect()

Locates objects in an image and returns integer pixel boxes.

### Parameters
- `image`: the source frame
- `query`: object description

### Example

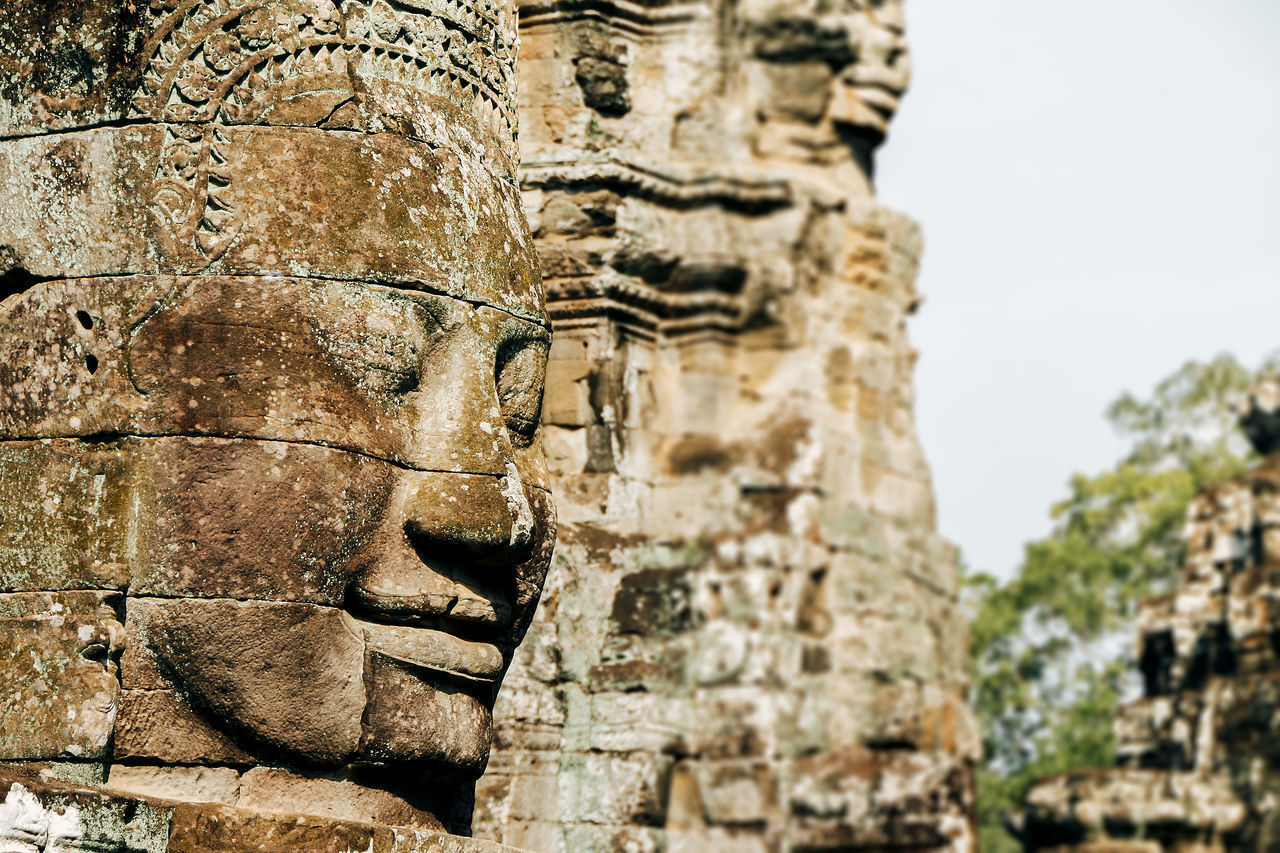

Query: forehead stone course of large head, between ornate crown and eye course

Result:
[0,126,543,320]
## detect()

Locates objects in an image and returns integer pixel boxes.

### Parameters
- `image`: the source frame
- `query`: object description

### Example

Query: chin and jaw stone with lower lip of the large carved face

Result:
[145,599,504,780]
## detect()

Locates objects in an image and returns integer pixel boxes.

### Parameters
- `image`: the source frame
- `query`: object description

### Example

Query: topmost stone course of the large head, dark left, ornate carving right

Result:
[0,0,516,173]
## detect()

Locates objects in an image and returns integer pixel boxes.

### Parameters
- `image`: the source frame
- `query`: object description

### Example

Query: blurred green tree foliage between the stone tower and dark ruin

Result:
[966,355,1280,853]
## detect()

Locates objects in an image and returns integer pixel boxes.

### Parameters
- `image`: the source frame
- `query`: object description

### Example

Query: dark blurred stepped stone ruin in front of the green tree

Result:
[1019,387,1280,853]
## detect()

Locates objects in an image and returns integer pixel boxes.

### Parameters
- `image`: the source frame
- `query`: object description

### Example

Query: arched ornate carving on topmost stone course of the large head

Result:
[129,0,516,136]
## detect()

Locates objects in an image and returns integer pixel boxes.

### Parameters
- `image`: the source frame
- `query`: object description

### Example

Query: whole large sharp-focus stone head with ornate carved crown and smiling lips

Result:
[0,0,554,849]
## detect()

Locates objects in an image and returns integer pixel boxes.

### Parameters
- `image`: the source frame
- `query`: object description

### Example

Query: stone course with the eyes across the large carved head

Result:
[0,275,548,485]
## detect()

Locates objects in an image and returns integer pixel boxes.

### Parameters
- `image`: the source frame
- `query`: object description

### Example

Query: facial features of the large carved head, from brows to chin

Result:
[113,279,553,776]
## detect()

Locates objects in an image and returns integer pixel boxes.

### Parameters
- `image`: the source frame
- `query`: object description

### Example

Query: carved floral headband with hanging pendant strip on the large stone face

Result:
[129,0,517,260]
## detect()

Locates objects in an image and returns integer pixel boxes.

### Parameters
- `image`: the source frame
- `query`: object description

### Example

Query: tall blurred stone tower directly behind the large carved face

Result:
[475,0,977,853]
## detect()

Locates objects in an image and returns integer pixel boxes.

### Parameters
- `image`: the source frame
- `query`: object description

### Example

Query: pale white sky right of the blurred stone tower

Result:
[878,0,1280,575]
